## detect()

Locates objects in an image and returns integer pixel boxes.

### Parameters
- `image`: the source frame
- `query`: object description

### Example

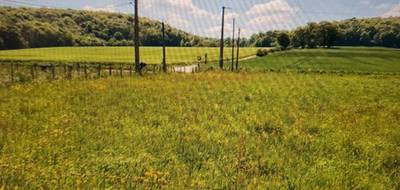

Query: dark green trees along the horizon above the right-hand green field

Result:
[246,17,400,48]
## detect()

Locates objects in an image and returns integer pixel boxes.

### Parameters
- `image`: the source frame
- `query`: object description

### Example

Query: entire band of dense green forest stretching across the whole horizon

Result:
[0,7,400,49]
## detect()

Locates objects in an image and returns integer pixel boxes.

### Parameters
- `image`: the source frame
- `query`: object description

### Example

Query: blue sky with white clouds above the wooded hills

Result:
[0,0,400,37]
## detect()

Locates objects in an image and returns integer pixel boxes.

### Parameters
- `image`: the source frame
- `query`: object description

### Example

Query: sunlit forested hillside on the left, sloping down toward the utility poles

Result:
[0,7,217,49]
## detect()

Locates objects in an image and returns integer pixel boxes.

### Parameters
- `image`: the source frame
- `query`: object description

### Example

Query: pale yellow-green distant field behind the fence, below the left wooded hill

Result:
[0,47,257,64]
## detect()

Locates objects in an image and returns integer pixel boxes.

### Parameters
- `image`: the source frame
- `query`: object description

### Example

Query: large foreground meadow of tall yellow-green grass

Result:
[0,72,400,189]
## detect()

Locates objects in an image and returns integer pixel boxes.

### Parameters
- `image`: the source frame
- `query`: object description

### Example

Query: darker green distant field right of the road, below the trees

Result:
[241,47,400,72]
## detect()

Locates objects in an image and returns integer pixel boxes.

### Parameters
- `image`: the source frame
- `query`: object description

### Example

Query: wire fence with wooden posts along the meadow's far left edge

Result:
[0,63,208,84]
